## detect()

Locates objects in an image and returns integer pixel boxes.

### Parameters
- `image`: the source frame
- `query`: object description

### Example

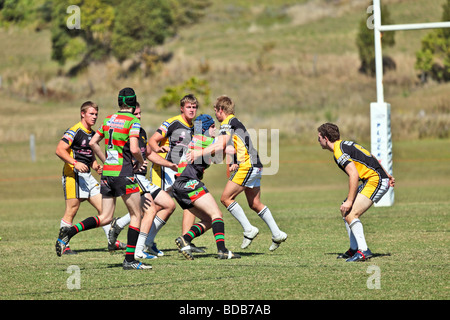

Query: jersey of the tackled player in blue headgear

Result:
[177,134,214,180]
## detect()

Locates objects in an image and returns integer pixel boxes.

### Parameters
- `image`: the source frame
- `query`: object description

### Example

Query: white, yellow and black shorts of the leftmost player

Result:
[61,171,100,200]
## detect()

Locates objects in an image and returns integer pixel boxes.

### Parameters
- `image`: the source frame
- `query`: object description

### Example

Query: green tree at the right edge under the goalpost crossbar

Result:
[415,0,450,82]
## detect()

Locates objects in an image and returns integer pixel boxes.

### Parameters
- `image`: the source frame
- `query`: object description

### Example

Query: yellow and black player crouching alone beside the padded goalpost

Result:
[317,123,395,262]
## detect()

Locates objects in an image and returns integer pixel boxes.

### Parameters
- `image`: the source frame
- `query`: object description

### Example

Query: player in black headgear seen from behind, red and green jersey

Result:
[56,88,152,270]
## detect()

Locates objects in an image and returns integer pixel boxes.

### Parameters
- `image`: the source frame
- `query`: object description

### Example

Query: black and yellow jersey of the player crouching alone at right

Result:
[333,140,387,180]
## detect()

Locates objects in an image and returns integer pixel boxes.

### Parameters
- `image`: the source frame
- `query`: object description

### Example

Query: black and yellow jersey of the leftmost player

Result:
[61,121,95,172]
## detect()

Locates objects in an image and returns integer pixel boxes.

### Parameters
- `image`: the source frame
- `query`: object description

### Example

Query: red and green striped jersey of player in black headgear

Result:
[97,111,141,177]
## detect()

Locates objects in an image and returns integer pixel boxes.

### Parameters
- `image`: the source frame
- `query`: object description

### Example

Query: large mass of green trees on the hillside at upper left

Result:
[0,0,210,73]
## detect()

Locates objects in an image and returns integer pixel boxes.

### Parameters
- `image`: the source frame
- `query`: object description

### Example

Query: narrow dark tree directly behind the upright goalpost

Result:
[356,1,395,76]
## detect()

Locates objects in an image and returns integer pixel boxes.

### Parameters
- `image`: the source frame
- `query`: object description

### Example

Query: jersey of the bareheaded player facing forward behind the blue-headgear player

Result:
[156,115,194,163]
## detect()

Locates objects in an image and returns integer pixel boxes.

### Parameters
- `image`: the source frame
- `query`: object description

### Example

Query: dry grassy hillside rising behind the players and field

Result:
[0,0,450,148]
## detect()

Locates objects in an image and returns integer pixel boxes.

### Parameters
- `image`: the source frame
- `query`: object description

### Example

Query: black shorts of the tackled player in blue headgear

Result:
[172,176,209,209]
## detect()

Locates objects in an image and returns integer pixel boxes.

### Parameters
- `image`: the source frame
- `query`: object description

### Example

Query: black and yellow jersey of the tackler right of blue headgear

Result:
[220,115,263,168]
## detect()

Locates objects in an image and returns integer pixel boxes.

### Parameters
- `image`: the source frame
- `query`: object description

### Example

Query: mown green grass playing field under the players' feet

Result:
[0,140,450,300]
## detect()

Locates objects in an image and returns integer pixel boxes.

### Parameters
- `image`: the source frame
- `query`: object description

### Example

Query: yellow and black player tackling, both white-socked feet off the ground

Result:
[192,96,287,251]
